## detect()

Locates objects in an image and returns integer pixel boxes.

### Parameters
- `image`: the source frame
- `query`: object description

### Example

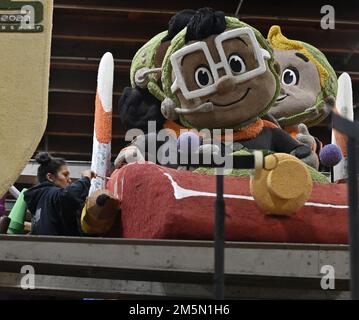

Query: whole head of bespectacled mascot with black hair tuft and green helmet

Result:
[162,8,278,129]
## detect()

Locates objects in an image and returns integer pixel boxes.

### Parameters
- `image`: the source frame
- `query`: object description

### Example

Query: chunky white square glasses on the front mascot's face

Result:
[171,27,270,100]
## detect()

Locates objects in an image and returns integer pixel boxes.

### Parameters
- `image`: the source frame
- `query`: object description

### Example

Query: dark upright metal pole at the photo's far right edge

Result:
[347,137,359,300]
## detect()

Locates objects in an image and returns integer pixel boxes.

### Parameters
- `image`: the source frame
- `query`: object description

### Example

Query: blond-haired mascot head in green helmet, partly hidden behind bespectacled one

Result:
[268,26,337,126]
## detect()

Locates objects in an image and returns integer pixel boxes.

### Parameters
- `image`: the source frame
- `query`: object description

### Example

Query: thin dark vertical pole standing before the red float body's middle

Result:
[214,168,225,300]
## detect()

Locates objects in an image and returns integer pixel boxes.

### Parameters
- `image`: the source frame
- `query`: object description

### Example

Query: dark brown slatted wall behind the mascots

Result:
[38,0,359,160]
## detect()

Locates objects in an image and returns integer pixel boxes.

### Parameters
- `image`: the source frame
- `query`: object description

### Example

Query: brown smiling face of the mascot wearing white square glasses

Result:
[171,28,276,128]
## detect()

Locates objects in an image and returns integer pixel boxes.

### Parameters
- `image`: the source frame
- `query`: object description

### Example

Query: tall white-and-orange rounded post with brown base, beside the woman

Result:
[81,52,118,234]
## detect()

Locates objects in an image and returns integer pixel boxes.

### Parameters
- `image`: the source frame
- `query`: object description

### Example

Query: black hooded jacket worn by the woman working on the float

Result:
[24,177,91,236]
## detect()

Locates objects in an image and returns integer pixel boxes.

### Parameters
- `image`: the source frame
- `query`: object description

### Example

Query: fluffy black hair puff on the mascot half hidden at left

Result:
[119,87,165,133]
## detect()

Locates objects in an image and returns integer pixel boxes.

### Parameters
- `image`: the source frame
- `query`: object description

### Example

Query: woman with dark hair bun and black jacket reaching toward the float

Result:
[24,153,96,236]
